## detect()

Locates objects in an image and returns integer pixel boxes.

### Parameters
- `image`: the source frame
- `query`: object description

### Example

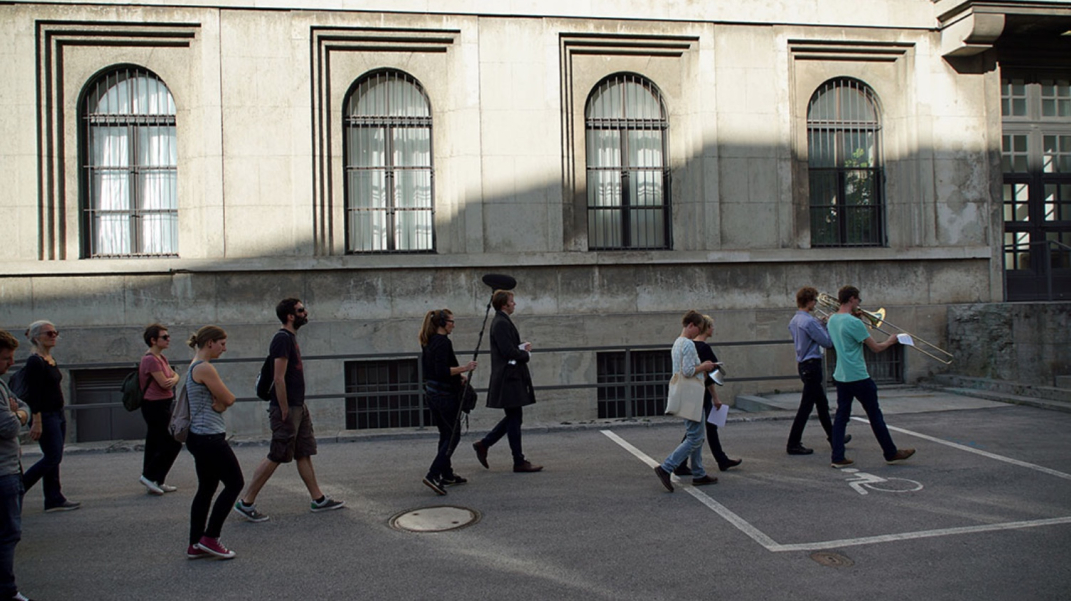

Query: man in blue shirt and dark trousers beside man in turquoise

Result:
[786,286,851,455]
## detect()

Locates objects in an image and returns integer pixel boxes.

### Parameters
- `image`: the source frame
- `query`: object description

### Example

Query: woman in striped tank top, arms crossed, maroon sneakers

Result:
[185,326,245,559]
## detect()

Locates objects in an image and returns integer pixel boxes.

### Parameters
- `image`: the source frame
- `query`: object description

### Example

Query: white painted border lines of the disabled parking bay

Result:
[600,426,1071,553]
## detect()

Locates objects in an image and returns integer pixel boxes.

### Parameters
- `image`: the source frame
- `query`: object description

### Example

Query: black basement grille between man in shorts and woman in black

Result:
[346,359,432,430]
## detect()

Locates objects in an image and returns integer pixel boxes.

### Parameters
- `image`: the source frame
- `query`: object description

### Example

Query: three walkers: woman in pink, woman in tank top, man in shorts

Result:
[138,298,345,559]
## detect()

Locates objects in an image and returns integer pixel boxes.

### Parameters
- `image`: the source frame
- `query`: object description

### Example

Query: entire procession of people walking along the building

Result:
[0,286,915,601]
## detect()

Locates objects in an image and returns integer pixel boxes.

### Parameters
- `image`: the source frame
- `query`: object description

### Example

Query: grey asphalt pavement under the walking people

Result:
[16,389,1071,601]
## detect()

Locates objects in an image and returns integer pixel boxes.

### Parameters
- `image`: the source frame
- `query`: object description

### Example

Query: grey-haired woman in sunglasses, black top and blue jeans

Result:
[22,319,81,512]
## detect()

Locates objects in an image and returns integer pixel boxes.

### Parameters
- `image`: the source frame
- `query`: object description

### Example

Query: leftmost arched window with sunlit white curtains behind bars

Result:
[80,67,179,257]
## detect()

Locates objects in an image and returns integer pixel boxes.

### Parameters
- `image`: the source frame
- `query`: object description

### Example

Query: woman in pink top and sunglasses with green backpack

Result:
[138,324,182,495]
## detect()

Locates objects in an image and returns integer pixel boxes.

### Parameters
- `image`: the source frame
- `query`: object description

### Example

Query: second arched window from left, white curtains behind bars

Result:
[343,71,435,253]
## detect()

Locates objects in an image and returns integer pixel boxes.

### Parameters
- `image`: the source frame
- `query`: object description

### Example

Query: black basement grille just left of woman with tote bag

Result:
[595,350,673,419]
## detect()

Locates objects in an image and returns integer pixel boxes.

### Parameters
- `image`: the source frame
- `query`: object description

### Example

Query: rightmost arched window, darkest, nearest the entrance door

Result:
[806,77,885,246]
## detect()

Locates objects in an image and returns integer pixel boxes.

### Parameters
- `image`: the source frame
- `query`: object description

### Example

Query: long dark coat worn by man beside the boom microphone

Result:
[487,311,536,409]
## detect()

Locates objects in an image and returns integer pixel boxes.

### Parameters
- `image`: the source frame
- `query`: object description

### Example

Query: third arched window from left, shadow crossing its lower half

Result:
[584,74,670,250]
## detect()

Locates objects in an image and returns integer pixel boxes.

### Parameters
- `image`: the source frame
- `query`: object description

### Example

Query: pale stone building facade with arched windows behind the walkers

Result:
[0,0,1071,439]
